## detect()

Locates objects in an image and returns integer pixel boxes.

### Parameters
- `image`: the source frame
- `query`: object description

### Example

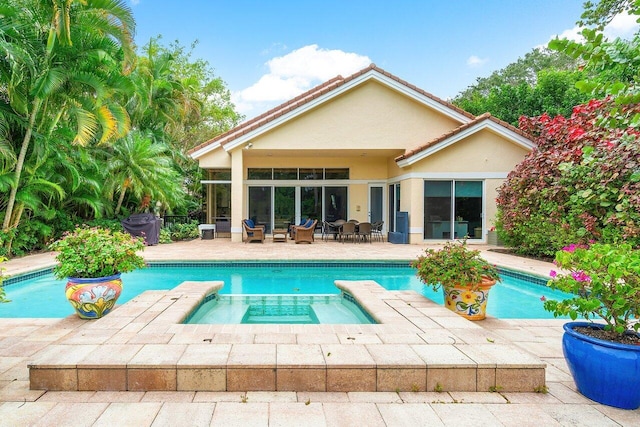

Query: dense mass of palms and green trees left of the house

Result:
[0,0,241,255]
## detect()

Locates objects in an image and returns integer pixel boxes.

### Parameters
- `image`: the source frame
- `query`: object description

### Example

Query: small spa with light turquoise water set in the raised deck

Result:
[184,294,375,324]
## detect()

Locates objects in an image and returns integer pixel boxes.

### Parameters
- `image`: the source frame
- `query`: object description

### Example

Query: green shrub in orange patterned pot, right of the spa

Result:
[411,239,500,320]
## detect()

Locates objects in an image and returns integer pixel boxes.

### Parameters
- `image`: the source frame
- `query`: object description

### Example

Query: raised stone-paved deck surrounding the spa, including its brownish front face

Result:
[28,280,546,392]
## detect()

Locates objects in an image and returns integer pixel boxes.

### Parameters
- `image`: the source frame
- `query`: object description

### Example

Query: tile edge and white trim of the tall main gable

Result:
[189,64,474,159]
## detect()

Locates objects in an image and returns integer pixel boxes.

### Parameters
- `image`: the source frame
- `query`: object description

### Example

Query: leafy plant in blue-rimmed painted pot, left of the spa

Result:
[49,226,144,319]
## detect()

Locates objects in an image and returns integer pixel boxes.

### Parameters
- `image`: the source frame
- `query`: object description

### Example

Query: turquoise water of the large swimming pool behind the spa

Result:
[0,262,565,319]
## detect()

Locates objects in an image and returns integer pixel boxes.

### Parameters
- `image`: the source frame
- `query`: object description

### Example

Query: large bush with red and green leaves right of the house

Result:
[496,99,640,257]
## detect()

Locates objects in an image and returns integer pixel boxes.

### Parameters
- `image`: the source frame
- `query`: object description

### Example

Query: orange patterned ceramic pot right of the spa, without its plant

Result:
[442,279,496,320]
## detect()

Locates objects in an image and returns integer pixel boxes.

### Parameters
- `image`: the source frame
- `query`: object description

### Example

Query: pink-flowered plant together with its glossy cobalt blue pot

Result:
[543,243,640,409]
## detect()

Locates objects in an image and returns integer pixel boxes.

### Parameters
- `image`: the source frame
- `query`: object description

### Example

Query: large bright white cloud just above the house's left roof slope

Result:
[232,44,371,116]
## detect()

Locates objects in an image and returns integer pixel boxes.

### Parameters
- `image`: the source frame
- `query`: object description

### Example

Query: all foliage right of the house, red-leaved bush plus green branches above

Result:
[497,1,640,257]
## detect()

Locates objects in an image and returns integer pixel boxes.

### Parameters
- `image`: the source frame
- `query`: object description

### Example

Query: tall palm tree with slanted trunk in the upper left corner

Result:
[0,0,135,236]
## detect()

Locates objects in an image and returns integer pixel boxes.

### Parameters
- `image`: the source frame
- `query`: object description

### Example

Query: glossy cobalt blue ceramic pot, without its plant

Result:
[562,322,640,409]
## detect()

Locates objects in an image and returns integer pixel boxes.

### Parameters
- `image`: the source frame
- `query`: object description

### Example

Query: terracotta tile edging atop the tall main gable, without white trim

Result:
[188,64,474,154]
